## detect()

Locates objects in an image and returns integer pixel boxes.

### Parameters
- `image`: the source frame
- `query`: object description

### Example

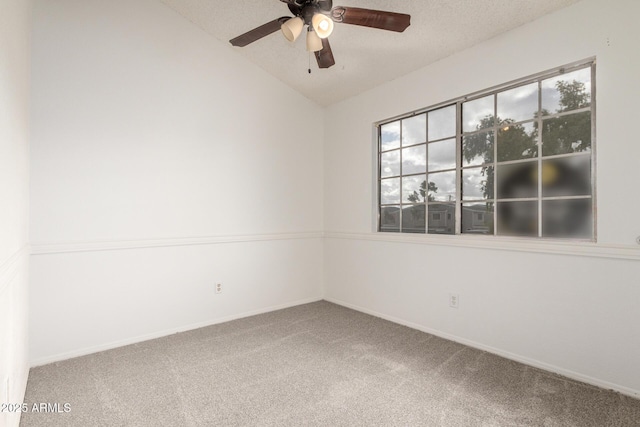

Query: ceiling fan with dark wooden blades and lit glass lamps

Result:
[229,0,411,72]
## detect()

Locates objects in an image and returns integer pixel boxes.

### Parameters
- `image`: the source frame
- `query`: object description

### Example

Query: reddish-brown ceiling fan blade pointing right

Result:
[331,6,411,33]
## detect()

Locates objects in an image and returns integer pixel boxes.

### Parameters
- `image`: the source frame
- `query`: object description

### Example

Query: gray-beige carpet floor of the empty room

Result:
[21,301,640,427]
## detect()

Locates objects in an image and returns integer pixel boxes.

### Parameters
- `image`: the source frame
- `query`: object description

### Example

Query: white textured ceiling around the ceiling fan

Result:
[160,0,579,106]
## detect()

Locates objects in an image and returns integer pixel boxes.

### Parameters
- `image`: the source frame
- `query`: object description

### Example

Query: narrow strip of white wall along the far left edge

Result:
[0,0,31,426]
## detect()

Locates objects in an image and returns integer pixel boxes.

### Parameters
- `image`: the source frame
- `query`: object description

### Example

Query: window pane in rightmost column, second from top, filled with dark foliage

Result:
[542,111,591,156]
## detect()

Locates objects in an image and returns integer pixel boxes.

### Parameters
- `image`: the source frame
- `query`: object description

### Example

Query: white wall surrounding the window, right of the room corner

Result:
[325,0,640,396]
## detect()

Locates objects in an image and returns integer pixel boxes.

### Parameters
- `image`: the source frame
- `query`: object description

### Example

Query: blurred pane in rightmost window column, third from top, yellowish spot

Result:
[542,156,591,197]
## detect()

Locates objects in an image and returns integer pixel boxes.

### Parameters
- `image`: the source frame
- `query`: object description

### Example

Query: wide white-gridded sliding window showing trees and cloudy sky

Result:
[378,62,595,240]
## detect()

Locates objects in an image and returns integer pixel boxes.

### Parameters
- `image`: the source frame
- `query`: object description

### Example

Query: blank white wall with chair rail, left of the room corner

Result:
[31,0,323,364]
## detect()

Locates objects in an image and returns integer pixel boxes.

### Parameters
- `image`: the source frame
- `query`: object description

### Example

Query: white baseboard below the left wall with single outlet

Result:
[31,296,322,368]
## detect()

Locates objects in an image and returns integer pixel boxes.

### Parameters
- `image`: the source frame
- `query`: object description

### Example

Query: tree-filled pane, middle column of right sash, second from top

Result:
[498,122,538,162]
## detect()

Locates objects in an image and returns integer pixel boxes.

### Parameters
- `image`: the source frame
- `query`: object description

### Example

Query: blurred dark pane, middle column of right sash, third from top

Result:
[497,161,538,199]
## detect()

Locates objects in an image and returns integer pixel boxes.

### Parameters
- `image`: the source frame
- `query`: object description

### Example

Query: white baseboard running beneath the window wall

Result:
[324,295,640,399]
